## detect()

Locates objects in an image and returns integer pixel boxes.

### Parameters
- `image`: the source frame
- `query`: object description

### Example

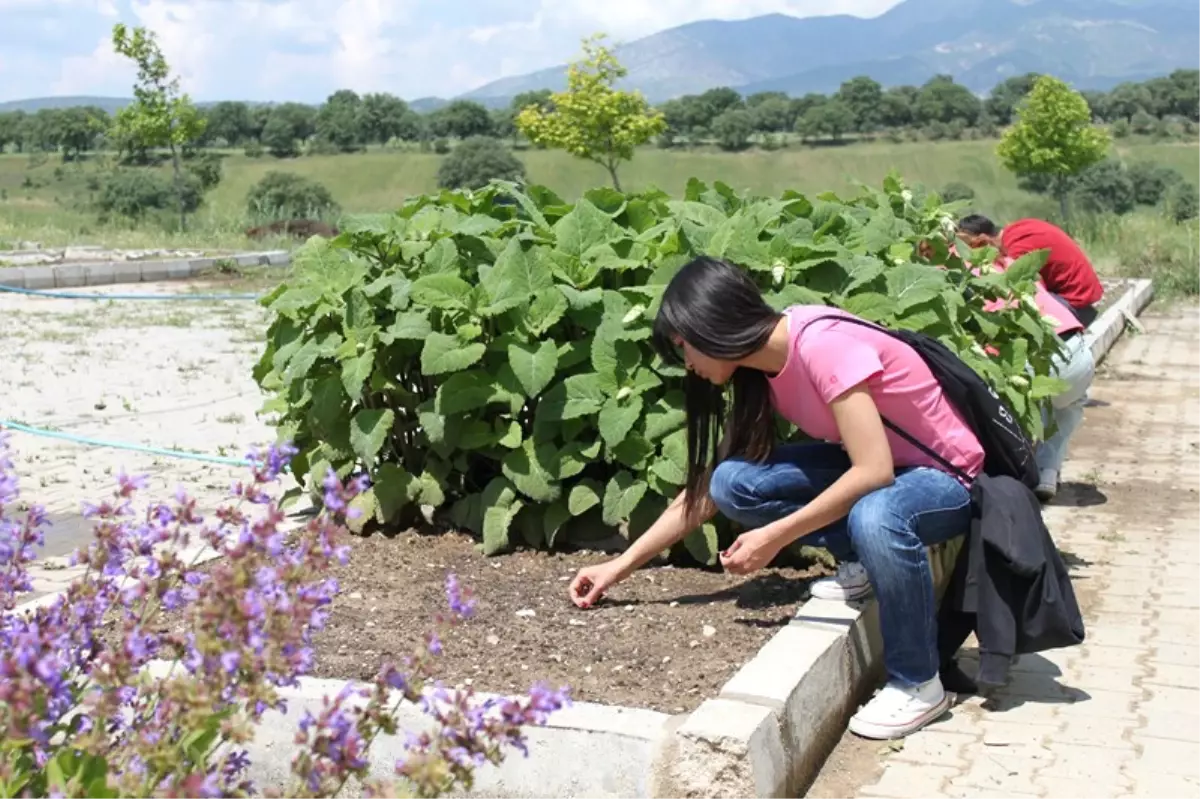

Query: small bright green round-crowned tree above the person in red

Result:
[996,76,1110,218]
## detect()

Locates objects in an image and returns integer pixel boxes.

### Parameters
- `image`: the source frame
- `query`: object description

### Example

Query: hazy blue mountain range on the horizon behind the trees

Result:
[0,0,1200,112]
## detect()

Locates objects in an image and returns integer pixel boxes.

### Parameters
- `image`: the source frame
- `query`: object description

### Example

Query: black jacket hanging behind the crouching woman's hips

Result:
[938,475,1084,686]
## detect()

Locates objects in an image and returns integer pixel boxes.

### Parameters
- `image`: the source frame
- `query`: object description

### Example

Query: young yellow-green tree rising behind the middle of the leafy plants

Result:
[517,36,666,191]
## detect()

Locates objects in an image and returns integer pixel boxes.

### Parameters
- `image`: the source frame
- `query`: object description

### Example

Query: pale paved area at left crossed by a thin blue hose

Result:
[0,282,275,599]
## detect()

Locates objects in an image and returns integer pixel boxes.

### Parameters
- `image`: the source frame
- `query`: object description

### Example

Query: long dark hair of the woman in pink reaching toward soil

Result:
[654,256,782,516]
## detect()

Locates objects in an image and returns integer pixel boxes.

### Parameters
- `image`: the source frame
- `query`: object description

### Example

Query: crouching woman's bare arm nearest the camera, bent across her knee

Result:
[721,383,895,573]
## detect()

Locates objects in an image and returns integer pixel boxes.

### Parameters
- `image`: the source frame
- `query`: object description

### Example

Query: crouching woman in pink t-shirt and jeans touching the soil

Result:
[570,258,984,739]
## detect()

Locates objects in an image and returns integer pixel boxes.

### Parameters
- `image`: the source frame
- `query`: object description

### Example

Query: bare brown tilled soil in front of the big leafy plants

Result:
[304,533,826,714]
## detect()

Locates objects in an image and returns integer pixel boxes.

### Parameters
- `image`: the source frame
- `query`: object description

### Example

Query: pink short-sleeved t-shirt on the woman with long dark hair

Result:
[769,305,984,477]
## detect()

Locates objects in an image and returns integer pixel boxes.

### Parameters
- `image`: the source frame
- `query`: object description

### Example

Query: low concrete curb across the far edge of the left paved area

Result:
[0,250,292,290]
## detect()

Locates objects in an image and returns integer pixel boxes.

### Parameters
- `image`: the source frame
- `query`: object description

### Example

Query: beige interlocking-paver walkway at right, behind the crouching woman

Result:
[858,307,1200,799]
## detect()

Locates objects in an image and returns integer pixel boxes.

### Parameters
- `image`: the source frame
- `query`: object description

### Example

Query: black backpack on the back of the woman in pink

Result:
[804,314,1039,489]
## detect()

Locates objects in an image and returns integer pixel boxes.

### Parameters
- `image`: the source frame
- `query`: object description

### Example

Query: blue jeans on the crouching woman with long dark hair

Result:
[709,443,971,685]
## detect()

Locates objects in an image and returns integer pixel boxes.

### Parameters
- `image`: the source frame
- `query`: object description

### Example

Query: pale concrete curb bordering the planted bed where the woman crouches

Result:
[4,280,1153,799]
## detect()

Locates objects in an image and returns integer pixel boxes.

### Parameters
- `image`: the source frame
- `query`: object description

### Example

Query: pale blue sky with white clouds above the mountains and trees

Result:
[0,0,899,102]
